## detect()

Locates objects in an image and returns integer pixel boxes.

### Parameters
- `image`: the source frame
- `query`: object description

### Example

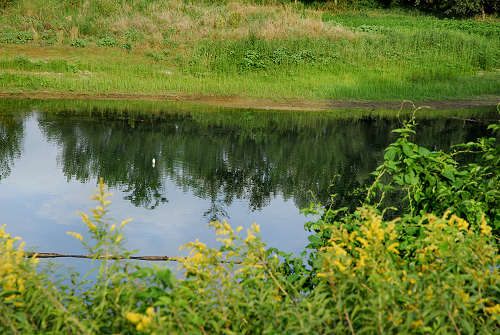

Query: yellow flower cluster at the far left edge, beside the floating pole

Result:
[0,225,38,307]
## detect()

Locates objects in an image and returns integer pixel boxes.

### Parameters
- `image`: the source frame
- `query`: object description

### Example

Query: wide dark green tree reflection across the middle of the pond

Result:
[39,111,492,219]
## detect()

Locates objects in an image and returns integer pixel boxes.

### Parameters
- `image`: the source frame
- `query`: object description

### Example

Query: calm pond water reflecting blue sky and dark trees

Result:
[0,101,494,266]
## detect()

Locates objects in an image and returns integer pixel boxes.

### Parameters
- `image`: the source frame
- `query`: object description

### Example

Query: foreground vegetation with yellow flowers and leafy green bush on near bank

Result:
[0,109,500,334]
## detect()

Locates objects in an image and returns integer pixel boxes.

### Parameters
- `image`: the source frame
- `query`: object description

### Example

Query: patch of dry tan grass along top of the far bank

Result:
[0,0,356,48]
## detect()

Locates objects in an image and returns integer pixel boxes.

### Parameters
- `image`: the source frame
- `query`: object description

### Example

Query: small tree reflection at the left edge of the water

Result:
[0,111,24,181]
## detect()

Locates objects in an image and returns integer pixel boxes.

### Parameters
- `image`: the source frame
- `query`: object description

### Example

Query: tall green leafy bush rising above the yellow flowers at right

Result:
[367,113,500,234]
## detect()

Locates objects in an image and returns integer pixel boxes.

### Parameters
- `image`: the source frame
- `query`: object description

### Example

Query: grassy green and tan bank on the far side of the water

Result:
[0,0,500,101]
